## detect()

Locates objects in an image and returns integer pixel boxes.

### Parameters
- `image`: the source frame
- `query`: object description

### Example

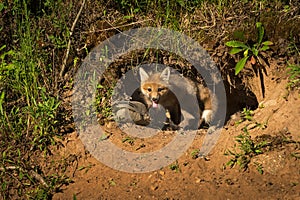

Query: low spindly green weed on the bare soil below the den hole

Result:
[225,128,267,173]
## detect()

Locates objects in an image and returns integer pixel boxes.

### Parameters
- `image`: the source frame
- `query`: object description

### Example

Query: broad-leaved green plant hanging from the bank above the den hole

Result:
[225,22,273,75]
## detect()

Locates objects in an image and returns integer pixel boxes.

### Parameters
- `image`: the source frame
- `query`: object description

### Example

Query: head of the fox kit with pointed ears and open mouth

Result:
[139,67,170,108]
